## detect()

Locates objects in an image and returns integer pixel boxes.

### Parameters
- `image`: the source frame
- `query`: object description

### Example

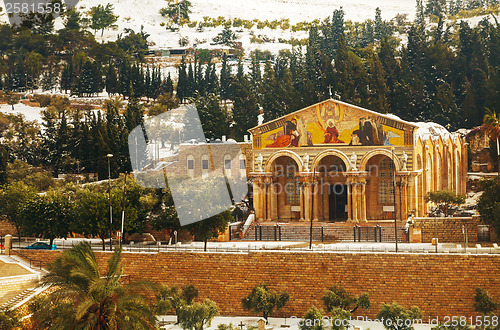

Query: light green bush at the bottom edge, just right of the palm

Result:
[179,298,219,330]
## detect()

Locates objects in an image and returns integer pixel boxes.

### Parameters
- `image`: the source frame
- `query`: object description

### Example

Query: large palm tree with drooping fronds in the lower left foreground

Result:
[33,243,156,329]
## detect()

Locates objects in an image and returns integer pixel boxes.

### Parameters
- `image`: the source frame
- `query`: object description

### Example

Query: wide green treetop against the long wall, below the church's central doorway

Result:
[321,285,370,313]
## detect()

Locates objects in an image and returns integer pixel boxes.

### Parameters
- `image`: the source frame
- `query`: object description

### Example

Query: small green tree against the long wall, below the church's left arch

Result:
[241,284,290,322]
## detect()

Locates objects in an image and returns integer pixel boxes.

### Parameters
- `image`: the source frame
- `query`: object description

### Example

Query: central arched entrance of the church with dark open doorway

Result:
[313,154,350,221]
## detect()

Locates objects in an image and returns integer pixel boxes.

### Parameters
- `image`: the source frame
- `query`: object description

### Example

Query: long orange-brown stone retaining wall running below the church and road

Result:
[18,251,500,320]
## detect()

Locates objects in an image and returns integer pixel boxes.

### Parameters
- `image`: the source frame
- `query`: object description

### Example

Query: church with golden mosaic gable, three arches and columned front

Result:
[249,99,467,222]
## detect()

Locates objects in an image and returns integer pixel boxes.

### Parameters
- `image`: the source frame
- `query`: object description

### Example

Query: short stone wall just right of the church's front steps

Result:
[414,216,498,243]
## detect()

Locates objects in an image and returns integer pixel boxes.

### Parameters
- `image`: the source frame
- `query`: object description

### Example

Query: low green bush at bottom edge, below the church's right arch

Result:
[377,302,422,330]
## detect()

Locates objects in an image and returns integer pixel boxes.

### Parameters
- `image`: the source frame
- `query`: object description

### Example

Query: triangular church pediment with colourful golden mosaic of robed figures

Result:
[249,99,417,148]
